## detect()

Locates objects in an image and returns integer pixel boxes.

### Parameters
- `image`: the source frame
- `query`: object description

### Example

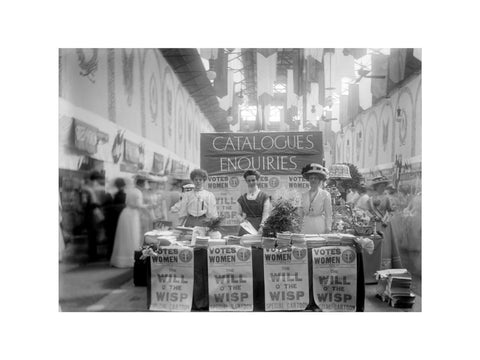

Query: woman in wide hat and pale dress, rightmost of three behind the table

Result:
[300,163,332,234]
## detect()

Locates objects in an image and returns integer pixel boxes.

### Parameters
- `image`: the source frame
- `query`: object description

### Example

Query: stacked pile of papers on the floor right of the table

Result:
[375,269,415,308]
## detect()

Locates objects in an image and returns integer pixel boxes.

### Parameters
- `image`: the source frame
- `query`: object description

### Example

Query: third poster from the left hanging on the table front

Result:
[263,246,309,311]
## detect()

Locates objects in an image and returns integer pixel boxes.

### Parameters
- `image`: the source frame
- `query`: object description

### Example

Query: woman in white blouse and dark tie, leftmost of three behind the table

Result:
[178,169,218,227]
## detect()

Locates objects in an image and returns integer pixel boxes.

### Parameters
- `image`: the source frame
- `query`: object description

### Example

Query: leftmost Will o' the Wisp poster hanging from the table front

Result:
[150,246,193,311]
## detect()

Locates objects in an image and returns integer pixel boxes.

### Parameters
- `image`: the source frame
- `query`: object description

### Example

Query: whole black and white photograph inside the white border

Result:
[59,48,422,312]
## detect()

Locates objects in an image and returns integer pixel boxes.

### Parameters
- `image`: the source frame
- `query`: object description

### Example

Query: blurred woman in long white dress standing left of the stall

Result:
[110,188,144,268]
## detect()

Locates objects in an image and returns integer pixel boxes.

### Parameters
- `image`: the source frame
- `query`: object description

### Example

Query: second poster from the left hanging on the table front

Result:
[208,245,253,311]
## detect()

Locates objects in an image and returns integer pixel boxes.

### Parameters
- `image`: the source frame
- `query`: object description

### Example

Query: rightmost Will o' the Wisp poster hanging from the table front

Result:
[312,246,357,311]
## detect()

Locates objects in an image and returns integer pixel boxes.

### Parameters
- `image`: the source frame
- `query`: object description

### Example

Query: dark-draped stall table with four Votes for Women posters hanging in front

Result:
[135,234,365,311]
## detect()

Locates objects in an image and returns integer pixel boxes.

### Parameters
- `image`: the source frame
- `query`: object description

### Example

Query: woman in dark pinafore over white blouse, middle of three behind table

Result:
[237,170,271,236]
